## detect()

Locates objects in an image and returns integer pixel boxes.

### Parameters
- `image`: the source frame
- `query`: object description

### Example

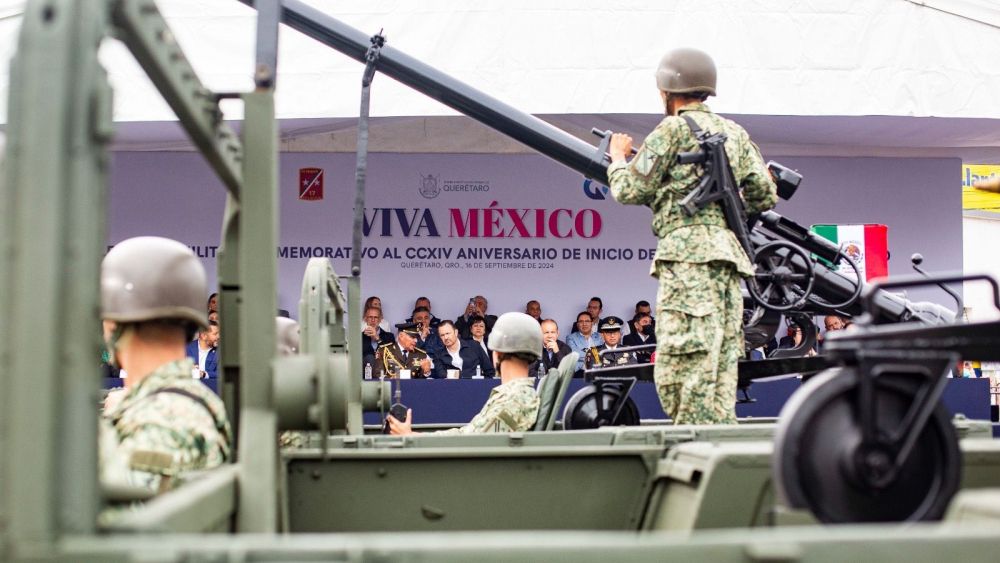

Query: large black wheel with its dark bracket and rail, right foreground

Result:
[773,274,1000,522]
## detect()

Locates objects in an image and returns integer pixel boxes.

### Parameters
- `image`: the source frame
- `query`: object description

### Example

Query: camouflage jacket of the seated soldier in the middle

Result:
[437,377,538,434]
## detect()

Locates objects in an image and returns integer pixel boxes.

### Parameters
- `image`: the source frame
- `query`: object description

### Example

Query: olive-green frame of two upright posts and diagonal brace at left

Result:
[0,0,278,558]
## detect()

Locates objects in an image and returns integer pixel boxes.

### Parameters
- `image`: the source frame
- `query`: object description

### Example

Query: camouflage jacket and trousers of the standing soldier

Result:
[608,102,777,424]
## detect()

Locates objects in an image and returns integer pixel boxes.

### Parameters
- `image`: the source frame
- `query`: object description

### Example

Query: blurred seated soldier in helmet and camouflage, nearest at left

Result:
[100,237,231,500]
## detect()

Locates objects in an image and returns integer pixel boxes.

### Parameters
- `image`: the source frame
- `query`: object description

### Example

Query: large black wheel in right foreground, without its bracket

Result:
[772,368,961,523]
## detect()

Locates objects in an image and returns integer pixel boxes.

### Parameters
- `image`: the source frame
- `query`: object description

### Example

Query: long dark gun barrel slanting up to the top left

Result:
[241,0,610,185]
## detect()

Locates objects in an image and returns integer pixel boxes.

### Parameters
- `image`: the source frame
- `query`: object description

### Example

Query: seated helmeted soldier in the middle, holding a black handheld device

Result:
[388,313,542,435]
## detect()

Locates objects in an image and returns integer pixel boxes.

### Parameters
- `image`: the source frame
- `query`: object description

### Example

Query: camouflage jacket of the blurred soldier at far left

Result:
[100,358,231,492]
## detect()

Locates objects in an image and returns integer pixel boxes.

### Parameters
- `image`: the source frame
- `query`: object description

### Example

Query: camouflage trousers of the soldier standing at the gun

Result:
[653,260,743,424]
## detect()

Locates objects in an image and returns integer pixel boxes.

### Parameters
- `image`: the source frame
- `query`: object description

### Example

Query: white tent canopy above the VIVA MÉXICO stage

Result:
[0,0,1000,162]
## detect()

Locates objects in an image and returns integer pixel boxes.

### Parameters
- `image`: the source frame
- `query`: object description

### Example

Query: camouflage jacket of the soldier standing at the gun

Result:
[608,103,778,276]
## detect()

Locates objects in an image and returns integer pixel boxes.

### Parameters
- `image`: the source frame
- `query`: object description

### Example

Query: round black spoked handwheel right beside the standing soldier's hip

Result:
[747,241,815,312]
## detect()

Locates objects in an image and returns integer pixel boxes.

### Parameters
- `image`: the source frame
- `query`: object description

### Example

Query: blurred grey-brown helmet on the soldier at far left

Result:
[101,237,208,328]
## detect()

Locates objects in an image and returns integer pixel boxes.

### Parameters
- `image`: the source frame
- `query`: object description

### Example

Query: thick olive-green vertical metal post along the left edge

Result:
[0,0,111,557]
